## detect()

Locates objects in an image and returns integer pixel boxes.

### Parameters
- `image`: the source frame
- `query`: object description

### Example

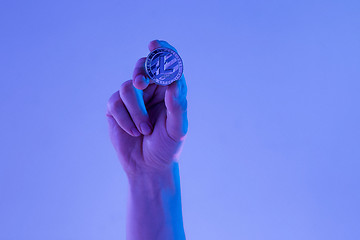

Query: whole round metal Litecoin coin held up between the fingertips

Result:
[145,48,183,86]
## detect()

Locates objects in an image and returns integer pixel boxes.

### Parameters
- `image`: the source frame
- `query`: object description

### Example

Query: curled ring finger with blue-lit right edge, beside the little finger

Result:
[119,80,152,135]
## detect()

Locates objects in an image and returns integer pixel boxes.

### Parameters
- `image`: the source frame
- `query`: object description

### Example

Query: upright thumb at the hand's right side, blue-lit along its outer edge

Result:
[165,75,188,141]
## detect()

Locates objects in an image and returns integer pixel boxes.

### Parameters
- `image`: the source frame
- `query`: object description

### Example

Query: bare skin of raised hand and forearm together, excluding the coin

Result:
[106,40,188,240]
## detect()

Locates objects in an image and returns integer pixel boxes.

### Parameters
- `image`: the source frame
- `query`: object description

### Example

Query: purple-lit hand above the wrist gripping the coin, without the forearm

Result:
[106,40,188,176]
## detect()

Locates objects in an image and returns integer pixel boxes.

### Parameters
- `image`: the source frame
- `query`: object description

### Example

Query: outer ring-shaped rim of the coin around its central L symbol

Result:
[145,47,184,86]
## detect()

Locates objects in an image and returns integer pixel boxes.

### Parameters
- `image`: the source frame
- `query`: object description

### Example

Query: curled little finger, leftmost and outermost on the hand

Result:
[106,91,141,137]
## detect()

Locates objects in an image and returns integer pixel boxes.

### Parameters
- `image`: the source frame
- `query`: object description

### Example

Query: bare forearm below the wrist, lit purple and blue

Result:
[126,162,185,240]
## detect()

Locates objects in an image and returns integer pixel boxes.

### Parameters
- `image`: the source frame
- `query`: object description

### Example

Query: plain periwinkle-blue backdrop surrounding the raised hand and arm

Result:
[0,0,360,240]
